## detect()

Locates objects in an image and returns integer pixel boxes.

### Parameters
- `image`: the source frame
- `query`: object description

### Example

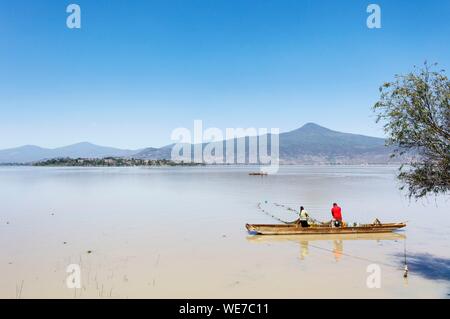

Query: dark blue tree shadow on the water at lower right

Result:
[395,253,450,282]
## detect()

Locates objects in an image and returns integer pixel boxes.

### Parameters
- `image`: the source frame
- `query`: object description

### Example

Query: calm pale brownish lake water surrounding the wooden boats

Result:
[0,166,450,298]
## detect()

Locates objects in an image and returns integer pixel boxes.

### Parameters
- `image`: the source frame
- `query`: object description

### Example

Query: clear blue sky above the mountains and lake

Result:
[0,0,450,148]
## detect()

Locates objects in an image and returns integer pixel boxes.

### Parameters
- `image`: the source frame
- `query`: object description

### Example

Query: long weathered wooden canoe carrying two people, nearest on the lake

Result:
[245,223,406,235]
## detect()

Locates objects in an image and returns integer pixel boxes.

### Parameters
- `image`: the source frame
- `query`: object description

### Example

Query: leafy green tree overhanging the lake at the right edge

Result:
[373,62,450,199]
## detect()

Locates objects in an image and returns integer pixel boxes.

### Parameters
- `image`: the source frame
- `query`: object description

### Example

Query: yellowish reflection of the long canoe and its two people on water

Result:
[247,233,406,262]
